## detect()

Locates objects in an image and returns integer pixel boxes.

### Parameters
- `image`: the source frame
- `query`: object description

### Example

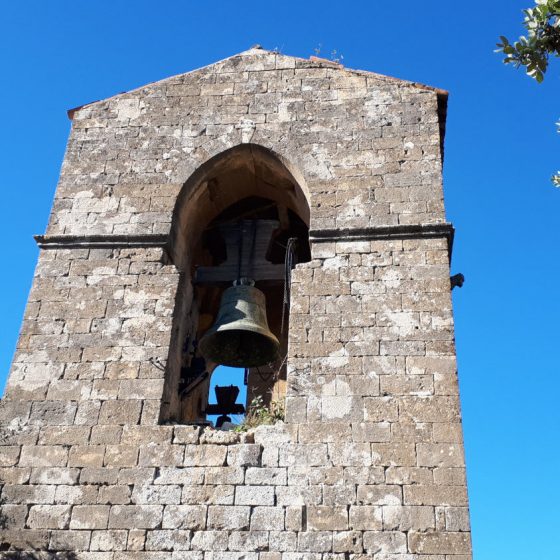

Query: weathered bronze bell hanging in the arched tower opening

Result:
[198,282,280,367]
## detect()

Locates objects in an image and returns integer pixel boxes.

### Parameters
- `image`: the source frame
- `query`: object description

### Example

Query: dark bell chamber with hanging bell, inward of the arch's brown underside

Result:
[169,195,309,424]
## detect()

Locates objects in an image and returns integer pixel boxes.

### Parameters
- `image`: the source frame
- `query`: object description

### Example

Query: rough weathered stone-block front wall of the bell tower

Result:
[0,49,470,560]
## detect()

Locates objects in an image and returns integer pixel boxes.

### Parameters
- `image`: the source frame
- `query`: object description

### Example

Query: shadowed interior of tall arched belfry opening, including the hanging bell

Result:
[162,147,310,423]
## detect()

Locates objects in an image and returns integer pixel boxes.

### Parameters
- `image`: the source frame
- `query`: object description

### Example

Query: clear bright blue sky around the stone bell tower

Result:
[0,0,560,560]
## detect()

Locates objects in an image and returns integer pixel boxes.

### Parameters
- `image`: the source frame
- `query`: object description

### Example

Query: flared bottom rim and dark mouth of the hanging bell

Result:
[200,329,278,368]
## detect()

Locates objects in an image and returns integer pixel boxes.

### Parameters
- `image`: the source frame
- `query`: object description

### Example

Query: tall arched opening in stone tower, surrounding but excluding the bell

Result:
[161,144,310,423]
